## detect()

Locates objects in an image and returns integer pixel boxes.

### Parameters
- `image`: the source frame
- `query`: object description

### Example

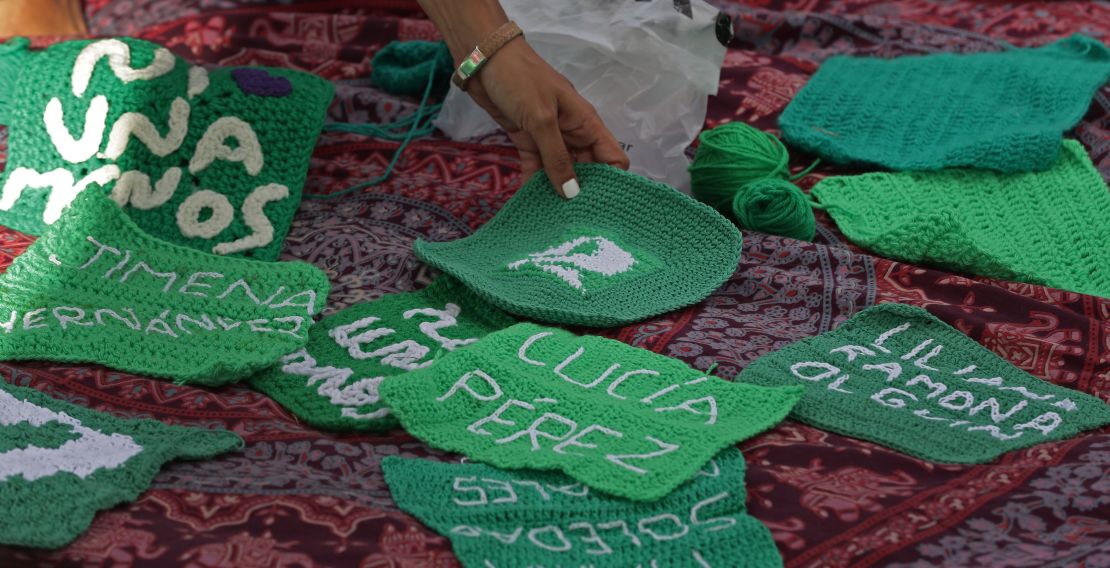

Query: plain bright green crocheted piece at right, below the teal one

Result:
[813,140,1110,297]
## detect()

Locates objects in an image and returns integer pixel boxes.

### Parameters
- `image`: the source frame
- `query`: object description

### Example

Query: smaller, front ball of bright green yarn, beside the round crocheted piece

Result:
[733,178,817,241]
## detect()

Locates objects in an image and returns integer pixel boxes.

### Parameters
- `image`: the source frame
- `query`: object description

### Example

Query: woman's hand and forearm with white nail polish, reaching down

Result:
[420,0,628,199]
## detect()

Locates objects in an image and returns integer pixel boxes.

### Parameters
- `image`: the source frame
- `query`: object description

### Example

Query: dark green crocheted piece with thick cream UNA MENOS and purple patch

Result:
[0,33,333,261]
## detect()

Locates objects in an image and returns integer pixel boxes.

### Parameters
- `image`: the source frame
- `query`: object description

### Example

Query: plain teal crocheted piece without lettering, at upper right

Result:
[779,34,1110,172]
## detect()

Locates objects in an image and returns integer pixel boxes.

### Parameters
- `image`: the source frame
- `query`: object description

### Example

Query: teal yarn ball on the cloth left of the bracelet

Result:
[370,40,455,97]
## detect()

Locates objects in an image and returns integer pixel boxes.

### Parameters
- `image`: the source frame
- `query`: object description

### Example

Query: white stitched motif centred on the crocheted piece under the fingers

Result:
[508,236,636,292]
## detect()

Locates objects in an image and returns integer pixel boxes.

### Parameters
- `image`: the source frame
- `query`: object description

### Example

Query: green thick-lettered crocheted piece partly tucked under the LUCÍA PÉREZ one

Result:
[251,276,513,430]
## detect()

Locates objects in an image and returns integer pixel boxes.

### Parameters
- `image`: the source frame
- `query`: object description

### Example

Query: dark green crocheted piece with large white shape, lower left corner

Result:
[0,381,243,548]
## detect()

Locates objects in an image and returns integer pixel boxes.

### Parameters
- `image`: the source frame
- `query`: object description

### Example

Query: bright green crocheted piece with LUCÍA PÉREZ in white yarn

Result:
[381,324,801,500]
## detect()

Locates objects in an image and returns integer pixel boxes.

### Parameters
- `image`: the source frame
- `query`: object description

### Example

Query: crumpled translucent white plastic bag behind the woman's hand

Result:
[435,0,727,193]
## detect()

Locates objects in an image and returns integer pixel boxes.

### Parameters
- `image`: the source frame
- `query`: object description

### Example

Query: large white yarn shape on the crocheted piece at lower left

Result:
[0,391,142,481]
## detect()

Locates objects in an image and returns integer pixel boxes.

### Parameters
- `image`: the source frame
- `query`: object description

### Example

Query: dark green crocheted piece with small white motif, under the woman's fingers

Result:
[414,164,740,326]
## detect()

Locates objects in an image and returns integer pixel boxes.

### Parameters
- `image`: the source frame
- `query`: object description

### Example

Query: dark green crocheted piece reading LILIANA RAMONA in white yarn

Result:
[737,304,1110,464]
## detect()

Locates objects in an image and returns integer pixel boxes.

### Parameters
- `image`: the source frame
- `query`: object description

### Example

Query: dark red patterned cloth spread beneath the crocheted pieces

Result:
[0,0,1110,567]
